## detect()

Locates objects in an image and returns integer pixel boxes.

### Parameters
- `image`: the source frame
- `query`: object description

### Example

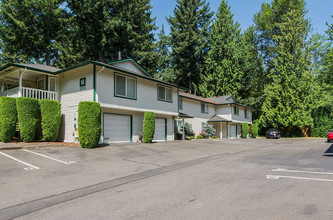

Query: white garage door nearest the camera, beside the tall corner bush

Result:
[104,114,131,143]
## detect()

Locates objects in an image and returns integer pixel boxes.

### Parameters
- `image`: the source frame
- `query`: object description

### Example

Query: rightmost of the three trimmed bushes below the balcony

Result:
[39,99,61,141]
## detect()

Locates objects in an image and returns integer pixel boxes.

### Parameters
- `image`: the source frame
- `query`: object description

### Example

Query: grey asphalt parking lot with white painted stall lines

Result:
[0,139,333,219]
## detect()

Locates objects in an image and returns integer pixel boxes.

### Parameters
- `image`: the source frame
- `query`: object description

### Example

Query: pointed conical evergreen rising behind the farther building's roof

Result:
[201,0,245,98]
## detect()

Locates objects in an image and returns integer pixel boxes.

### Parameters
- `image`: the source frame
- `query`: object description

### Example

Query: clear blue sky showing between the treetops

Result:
[151,0,333,34]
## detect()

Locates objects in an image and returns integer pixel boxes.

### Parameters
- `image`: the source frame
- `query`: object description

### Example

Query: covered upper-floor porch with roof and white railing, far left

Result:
[0,64,59,100]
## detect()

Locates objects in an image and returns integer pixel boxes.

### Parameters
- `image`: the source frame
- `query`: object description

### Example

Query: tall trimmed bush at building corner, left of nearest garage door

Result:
[78,102,102,148]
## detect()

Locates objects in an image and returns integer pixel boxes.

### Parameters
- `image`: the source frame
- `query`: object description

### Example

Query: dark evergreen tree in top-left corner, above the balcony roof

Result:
[0,0,68,66]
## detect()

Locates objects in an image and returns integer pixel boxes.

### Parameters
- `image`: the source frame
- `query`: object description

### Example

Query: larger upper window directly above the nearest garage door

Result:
[115,74,136,99]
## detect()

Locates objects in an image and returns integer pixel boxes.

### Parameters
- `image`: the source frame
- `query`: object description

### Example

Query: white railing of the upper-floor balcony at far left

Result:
[0,87,58,100]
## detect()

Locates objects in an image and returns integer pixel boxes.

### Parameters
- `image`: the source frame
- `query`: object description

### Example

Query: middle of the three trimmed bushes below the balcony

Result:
[16,97,38,142]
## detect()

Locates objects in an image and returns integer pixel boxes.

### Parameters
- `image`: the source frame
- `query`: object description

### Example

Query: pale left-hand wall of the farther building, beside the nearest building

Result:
[180,97,215,136]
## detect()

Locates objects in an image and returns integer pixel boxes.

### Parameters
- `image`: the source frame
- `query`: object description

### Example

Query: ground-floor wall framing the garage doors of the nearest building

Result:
[101,108,174,142]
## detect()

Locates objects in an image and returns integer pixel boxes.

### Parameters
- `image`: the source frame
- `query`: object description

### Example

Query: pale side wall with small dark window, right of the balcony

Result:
[58,65,93,142]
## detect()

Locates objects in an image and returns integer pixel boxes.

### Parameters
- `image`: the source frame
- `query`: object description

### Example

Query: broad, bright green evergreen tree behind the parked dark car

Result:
[260,0,317,128]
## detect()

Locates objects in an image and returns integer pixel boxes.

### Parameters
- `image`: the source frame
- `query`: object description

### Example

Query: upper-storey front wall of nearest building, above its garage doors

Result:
[96,68,178,115]
